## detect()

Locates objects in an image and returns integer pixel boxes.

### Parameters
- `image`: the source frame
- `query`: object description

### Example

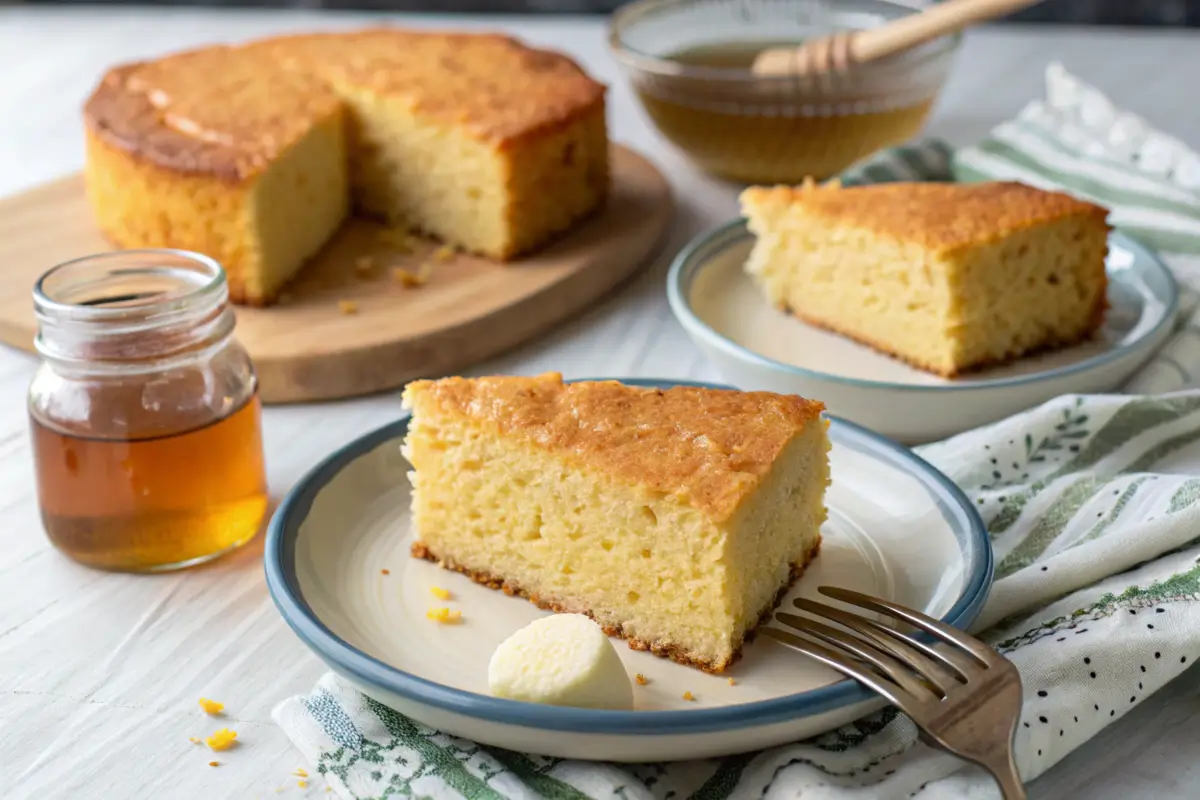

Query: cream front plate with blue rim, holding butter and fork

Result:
[264,380,992,762]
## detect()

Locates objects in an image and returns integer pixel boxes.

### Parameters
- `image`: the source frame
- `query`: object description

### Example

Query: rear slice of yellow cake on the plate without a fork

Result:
[742,182,1109,378]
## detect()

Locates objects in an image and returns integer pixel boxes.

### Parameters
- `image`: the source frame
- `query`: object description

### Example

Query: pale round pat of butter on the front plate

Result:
[487,614,634,711]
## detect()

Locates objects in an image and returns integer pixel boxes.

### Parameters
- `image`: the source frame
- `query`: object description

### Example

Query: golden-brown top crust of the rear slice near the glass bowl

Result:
[742,181,1108,252]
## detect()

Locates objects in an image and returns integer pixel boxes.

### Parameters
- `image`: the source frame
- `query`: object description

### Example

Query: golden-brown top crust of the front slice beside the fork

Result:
[404,373,824,519]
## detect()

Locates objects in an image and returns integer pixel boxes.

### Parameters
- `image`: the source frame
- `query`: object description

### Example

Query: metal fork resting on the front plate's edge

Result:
[760,587,1025,800]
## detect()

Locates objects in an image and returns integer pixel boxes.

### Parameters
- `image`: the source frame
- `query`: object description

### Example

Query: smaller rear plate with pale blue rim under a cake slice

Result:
[667,221,1177,443]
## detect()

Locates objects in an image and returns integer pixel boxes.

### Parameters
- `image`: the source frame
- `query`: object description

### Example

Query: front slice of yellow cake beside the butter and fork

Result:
[404,374,829,672]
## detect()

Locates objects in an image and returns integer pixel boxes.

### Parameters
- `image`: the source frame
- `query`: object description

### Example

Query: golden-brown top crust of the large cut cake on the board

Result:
[84,28,605,180]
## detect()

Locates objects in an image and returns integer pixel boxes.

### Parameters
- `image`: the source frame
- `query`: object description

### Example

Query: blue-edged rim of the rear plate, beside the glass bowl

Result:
[667,217,1180,392]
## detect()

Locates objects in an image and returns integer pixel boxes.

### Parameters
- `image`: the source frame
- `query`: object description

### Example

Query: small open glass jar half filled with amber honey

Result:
[29,249,268,572]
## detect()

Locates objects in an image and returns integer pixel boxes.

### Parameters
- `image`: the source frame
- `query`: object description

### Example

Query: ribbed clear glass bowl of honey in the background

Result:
[608,0,960,184]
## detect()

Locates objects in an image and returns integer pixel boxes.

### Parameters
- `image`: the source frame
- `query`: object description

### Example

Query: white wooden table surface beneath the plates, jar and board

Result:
[0,7,1200,800]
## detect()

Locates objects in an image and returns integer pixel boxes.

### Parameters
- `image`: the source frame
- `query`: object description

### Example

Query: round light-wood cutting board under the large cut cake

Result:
[0,146,673,403]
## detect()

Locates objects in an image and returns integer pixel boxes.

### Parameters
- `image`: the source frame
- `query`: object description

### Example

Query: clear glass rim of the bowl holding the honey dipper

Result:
[605,0,962,82]
